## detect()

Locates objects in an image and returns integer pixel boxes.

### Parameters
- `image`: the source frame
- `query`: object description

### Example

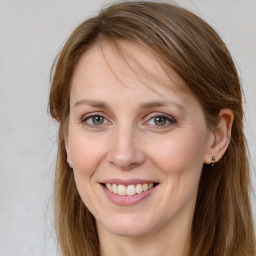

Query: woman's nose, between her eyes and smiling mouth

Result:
[107,128,146,170]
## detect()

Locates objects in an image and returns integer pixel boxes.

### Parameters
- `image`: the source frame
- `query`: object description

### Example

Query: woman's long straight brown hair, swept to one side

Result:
[49,1,255,256]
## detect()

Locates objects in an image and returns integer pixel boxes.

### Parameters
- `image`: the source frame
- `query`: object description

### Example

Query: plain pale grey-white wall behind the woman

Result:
[0,0,256,256]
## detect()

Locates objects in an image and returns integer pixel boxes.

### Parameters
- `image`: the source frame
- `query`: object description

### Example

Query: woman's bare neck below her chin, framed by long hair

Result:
[99,217,191,256]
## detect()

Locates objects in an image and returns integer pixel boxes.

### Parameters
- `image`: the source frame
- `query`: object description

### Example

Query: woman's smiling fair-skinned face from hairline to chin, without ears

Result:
[66,42,213,236]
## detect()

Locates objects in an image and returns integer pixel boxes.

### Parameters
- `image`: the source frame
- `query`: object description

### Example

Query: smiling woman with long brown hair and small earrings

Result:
[49,2,255,256]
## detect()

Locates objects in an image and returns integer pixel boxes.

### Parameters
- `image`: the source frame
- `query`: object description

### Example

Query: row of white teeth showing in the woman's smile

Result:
[106,183,153,196]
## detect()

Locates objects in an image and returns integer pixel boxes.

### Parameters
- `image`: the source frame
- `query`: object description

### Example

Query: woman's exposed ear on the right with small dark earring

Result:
[204,109,234,164]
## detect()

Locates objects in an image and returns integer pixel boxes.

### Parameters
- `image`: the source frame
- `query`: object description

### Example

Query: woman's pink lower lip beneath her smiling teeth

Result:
[102,186,155,206]
